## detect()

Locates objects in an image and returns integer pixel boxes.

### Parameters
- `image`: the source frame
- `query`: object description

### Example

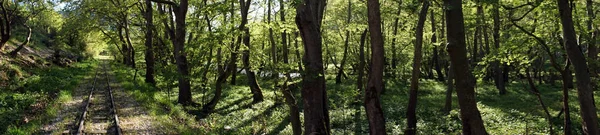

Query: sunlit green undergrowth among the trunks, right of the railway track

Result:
[113,61,600,134]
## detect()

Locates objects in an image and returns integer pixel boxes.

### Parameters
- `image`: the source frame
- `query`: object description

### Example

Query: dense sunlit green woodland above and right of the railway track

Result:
[0,0,600,135]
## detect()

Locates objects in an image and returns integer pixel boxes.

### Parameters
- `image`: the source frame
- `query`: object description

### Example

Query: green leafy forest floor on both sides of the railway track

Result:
[0,49,600,135]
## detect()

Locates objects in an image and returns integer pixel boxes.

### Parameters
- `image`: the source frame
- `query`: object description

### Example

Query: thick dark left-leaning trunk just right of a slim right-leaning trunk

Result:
[444,0,487,135]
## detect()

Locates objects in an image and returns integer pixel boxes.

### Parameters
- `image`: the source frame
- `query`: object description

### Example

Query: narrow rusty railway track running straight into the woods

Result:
[75,62,122,135]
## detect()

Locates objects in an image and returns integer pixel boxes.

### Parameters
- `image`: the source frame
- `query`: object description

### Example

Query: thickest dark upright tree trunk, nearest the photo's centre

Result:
[296,0,331,134]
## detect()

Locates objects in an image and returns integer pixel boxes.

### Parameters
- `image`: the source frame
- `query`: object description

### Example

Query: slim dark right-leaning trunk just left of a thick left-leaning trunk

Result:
[404,1,433,135]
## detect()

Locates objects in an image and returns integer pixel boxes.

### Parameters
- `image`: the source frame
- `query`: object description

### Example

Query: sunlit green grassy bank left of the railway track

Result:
[0,61,96,135]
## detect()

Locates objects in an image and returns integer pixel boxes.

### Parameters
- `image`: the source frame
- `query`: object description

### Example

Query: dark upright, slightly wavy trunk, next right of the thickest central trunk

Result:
[365,0,386,135]
